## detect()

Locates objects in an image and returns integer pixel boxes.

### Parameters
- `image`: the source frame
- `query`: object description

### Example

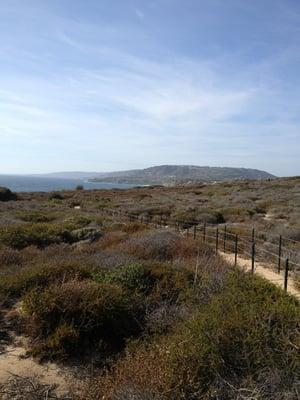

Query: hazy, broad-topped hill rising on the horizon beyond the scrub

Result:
[93,165,275,185]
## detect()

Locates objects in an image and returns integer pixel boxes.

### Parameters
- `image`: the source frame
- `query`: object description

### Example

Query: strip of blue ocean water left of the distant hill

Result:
[0,175,134,192]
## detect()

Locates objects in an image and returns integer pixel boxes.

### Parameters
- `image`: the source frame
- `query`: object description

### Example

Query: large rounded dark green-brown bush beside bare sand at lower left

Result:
[23,281,140,358]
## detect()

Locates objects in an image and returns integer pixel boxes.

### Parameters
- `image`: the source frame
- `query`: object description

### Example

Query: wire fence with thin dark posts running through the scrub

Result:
[106,210,300,290]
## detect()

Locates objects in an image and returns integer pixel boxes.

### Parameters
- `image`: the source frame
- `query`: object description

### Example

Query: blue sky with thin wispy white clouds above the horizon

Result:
[0,0,300,175]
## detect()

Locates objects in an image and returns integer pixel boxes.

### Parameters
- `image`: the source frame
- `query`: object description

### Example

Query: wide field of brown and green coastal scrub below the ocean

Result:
[0,179,300,400]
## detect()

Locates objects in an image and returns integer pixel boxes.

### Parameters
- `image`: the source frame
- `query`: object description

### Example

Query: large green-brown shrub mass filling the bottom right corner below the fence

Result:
[82,273,300,400]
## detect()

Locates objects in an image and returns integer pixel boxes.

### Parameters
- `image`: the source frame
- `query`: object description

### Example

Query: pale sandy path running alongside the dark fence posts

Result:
[220,252,300,300]
